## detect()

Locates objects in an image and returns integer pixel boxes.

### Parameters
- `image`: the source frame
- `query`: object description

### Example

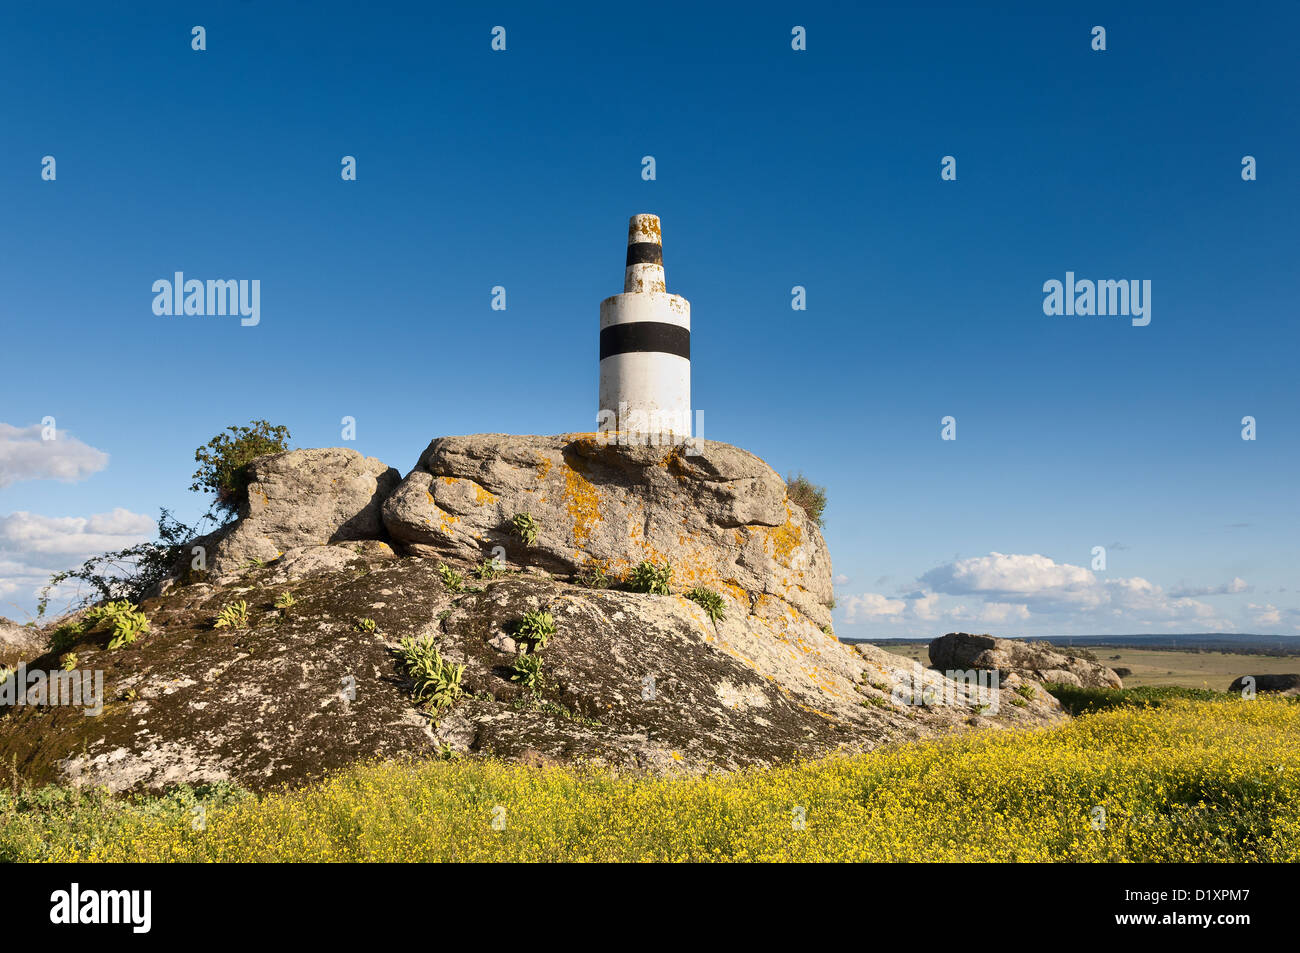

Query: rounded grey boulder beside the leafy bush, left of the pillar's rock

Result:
[196,447,402,577]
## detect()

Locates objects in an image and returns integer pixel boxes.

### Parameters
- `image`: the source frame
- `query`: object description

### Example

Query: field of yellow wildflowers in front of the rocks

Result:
[0,697,1300,862]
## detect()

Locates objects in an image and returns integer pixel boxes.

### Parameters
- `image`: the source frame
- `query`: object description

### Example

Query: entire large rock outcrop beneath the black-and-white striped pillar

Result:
[0,434,1065,790]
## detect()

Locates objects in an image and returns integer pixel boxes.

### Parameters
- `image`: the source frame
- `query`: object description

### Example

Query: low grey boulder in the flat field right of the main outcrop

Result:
[930,632,1123,688]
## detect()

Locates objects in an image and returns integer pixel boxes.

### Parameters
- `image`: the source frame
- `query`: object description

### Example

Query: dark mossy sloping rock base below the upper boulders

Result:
[0,543,1063,790]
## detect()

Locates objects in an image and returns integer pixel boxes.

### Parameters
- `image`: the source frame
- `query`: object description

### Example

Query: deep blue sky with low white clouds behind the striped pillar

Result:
[0,3,1300,637]
